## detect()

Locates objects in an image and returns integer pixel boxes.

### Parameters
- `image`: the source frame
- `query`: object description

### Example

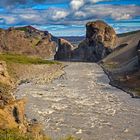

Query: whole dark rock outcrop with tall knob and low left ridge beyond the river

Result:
[56,21,117,62]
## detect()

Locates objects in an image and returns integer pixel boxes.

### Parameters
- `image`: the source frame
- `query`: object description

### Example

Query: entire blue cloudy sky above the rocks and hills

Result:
[0,0,140,36]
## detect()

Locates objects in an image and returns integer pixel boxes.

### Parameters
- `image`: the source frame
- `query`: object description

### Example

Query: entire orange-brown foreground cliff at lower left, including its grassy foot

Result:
[0,61,45,140]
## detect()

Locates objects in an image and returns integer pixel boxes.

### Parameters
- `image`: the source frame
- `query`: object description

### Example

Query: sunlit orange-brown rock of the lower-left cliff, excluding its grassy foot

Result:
[0,61,27,132]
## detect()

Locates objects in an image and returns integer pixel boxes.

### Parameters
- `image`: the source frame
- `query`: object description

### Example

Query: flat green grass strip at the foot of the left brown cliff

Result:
[0,53,59,64]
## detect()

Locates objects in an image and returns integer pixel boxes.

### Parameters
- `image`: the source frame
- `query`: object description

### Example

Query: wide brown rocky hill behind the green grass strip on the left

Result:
[0,26,57,58]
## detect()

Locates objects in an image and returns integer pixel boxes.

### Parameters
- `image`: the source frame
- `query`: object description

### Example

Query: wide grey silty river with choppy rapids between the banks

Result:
[16,63,140,140]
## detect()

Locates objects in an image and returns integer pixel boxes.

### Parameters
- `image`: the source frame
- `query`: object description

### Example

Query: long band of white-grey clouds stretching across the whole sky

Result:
[0,0,140,25]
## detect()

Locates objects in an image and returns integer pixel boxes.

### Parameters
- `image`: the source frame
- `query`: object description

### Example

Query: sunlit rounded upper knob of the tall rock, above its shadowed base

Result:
[86,20,117,49]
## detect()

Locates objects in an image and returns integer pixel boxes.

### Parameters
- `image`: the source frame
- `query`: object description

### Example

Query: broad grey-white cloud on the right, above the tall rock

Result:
[75,5,140,20]
